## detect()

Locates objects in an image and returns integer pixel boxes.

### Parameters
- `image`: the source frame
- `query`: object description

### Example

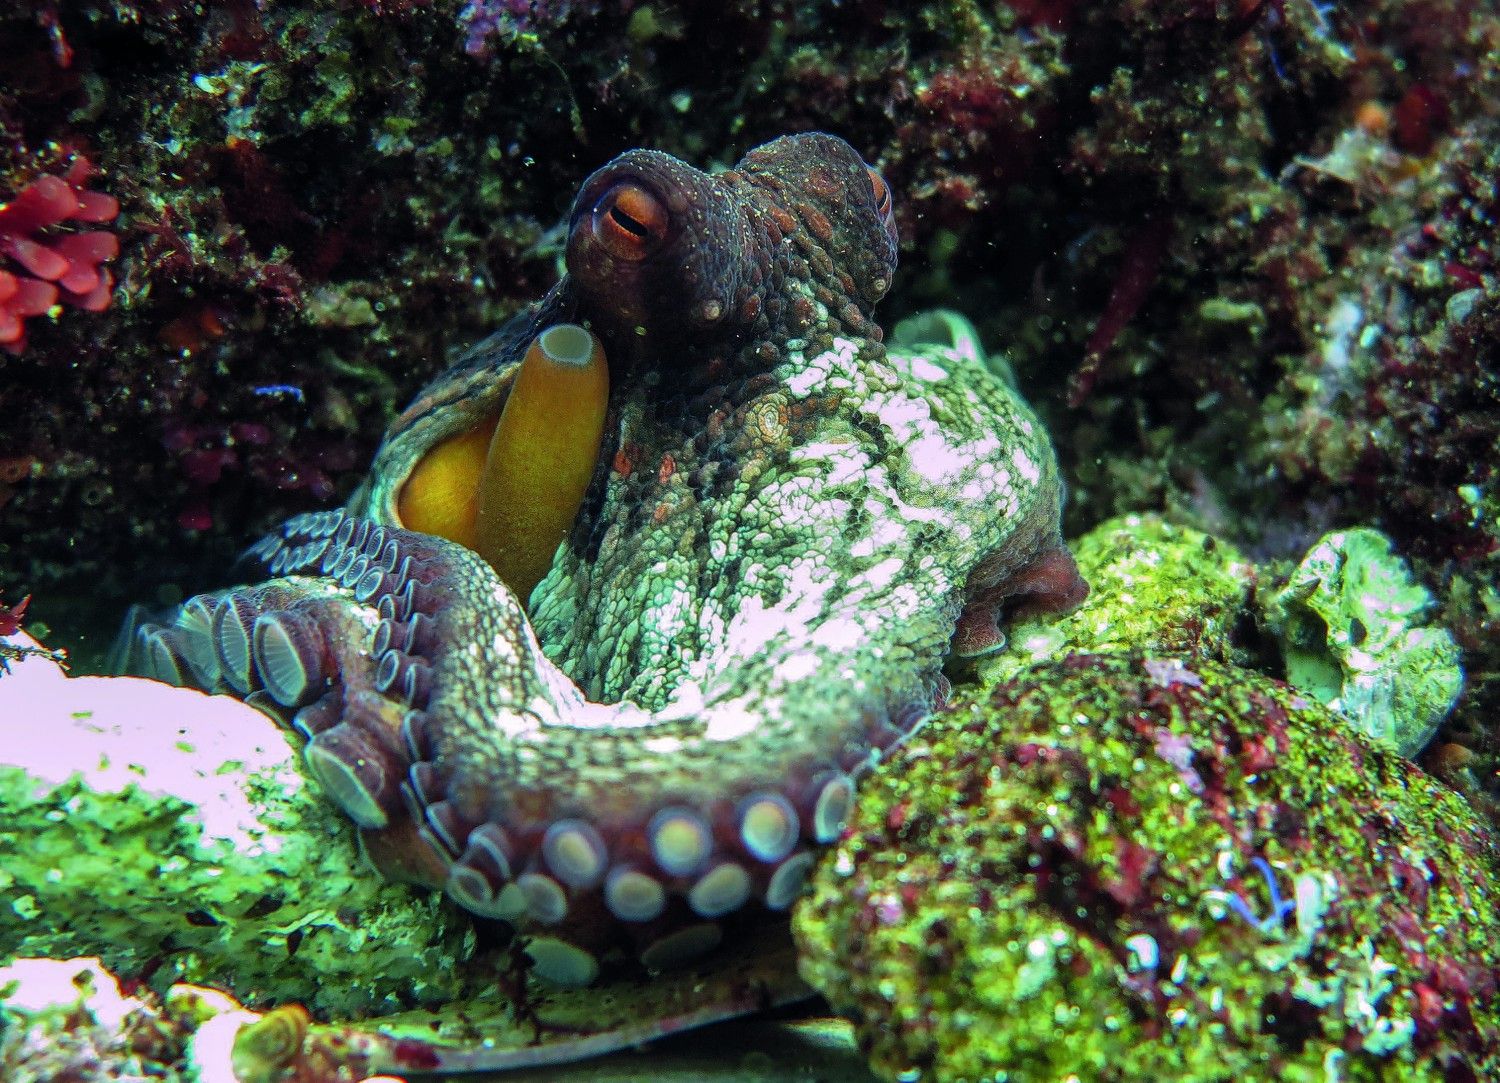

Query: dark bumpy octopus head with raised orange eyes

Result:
[567,134,896,359]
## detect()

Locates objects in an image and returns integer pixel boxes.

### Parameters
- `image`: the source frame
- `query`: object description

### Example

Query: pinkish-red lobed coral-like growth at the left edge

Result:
[0,156,120,354]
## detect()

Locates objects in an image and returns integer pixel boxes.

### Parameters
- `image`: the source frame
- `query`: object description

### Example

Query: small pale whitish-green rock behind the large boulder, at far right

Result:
[1266,528,1464,756]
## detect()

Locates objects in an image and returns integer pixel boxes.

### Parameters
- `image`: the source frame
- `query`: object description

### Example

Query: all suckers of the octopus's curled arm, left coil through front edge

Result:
[135,512,876,984]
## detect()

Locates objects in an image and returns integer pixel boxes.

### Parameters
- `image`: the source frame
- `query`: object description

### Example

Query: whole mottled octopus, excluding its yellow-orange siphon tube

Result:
[129,135,1086,983]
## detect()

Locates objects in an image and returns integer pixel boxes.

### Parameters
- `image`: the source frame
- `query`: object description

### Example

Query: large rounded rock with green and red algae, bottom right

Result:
[794,656,1500,1083]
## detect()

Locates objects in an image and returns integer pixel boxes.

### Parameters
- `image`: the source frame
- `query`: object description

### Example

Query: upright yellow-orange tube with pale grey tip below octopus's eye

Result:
[471,324,609,600]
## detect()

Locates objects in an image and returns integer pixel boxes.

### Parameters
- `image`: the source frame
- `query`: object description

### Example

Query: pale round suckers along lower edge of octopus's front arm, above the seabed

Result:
[402,663,854,984]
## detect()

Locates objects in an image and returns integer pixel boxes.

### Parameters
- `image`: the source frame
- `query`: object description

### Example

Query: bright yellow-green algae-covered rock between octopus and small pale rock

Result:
[978,515,1256,684]
